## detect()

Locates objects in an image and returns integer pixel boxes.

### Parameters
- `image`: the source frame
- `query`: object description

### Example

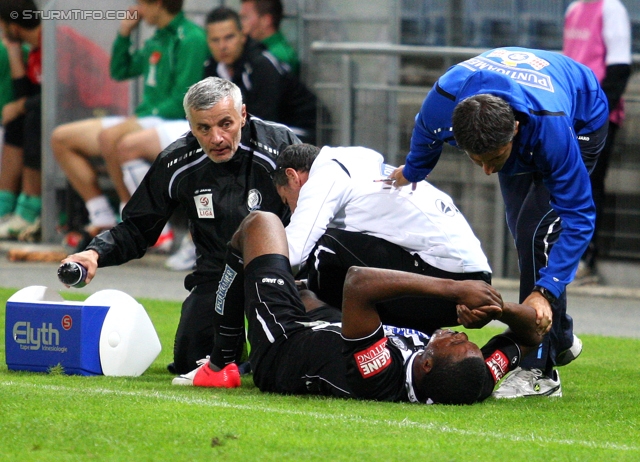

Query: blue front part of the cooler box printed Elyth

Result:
[5,301,109,375]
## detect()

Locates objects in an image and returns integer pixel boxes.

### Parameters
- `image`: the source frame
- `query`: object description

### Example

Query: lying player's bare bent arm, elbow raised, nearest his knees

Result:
[342,266,502,338]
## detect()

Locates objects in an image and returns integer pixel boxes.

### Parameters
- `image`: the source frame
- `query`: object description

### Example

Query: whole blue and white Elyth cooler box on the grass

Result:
[5,286,162,377]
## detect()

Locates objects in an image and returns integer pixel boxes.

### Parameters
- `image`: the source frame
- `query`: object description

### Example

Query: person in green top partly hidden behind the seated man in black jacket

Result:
[240,0,300,75]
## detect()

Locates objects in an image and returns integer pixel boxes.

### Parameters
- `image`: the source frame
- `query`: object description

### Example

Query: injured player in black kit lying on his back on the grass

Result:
[173,212,542,404]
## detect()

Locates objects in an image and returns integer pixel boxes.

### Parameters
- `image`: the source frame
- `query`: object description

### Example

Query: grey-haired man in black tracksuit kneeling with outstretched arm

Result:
[63,77,300,374]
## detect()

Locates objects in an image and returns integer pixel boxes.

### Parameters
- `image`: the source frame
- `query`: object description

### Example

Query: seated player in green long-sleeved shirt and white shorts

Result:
[51,0,208,250]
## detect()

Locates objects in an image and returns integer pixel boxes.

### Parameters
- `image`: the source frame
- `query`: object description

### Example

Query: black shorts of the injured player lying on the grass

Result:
[244,254,350,396]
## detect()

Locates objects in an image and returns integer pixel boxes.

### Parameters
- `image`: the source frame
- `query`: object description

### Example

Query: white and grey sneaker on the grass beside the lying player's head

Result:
[493,367,562,399]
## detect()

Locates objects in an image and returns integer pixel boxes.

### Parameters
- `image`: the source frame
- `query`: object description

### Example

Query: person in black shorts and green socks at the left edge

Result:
[0,0,42,240]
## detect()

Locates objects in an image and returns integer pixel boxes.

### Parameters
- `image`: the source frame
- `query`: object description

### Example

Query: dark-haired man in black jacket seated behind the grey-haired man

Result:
[205,7,317,143]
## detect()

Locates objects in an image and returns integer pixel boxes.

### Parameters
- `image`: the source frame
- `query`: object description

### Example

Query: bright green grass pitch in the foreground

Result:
[0,289,640,461]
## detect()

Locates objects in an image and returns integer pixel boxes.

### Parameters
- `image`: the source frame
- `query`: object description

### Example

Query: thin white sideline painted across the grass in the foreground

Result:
[0,381,640,451]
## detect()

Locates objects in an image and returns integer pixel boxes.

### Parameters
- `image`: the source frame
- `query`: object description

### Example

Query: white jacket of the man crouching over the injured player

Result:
[286,146,491,273]
